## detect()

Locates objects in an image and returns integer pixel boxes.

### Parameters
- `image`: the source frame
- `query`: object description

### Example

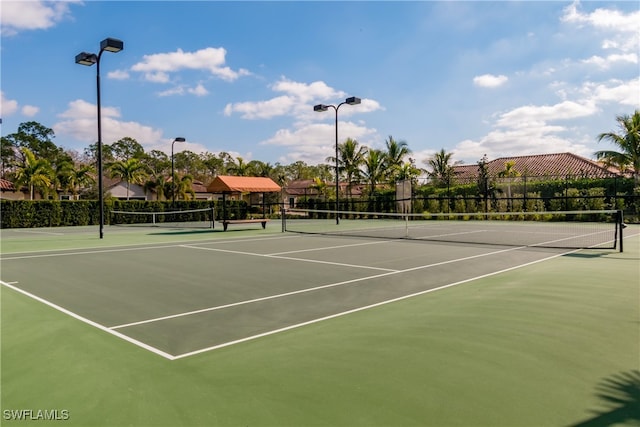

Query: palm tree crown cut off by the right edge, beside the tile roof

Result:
[595,110,640,186]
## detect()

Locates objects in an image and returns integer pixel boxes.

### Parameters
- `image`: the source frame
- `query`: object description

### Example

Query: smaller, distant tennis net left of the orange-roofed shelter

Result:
[110,208,215,228]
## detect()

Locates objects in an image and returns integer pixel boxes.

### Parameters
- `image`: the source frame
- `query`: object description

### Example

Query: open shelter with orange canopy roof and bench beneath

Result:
[207,175,281,231]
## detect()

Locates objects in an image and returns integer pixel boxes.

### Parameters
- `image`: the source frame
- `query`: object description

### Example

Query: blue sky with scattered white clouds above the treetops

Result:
[0,0,640,166]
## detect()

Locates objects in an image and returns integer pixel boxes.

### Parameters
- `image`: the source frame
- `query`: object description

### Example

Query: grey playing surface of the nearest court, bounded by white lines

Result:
[2,211,632,360]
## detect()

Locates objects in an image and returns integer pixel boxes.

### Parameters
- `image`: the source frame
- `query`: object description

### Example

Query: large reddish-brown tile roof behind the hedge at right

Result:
[453,153,616,179]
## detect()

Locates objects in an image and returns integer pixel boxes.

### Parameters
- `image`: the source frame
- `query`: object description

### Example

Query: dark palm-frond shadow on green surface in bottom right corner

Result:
[572,370,640,427]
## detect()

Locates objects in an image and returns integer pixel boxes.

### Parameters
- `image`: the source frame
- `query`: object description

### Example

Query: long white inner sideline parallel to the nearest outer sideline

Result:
[111,247,522,329]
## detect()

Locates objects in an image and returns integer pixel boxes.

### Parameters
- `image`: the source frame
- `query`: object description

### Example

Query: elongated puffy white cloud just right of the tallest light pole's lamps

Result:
[131,47,251,83]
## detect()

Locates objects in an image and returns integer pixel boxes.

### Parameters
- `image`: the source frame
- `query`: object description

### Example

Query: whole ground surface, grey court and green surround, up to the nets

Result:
[0,226,640,426]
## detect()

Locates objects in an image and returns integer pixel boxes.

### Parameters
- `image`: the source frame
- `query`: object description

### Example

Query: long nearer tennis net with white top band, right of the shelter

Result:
[283,209,624,250]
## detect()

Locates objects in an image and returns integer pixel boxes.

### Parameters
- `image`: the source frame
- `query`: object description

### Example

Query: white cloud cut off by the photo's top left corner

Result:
[0,0,81,36]
